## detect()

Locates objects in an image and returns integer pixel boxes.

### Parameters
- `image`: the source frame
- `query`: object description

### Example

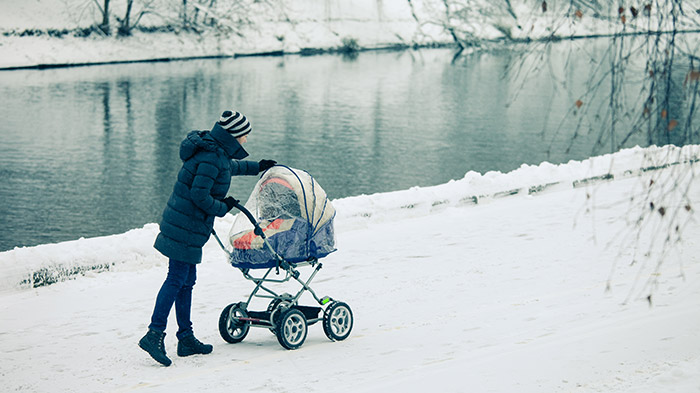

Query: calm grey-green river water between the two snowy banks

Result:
[0,41,696,250]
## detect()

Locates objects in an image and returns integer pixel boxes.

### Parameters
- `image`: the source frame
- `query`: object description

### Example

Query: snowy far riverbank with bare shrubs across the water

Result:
[0,0,700,70]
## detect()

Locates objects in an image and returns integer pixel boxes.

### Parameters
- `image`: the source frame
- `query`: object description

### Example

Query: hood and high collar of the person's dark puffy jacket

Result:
[180,124,248,161]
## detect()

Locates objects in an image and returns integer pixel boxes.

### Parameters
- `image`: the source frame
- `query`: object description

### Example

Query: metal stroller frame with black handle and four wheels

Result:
[213,202,353,349]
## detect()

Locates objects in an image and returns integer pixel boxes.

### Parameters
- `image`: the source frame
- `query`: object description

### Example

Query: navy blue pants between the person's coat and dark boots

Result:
[148,259,197,339]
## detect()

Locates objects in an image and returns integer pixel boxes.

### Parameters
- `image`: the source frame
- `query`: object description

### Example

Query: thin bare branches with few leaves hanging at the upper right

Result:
[444,0,700,302]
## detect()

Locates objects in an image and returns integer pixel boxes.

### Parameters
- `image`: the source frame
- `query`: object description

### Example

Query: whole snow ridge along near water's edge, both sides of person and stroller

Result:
[0,145,700,290]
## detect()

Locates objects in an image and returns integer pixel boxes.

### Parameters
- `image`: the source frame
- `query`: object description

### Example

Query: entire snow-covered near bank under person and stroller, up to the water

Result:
[0,146,700,393]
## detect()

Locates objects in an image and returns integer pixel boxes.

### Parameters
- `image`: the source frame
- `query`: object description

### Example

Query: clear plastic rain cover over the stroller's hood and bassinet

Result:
[229,165,336,269]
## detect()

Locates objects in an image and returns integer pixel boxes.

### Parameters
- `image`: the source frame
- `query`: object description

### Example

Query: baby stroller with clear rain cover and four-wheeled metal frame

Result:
[214,165,353,349]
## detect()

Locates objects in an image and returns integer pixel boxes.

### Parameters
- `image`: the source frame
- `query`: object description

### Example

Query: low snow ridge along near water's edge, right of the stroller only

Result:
[333,145,700,230]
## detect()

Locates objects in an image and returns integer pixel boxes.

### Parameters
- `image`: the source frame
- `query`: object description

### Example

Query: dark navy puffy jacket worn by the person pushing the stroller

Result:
[154,124,260,263]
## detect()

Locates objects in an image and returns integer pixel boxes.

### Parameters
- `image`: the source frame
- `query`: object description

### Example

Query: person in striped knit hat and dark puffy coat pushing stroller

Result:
[139,111,276,366]
